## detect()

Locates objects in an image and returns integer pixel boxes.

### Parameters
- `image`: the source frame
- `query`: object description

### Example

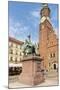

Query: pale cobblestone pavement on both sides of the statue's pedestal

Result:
[9,77,58,88]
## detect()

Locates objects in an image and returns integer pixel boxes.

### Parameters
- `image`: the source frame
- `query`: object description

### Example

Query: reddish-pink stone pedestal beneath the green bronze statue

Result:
[19,56,44,85]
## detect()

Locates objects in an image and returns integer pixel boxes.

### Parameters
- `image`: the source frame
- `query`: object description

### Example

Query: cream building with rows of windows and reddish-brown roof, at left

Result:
[9,37,23,63]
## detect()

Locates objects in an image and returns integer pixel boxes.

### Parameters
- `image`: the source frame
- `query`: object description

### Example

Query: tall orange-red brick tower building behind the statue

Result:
[39,4,58,72]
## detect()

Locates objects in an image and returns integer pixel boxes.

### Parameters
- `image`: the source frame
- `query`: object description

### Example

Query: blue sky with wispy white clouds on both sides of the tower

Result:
[8,1,58,43]
